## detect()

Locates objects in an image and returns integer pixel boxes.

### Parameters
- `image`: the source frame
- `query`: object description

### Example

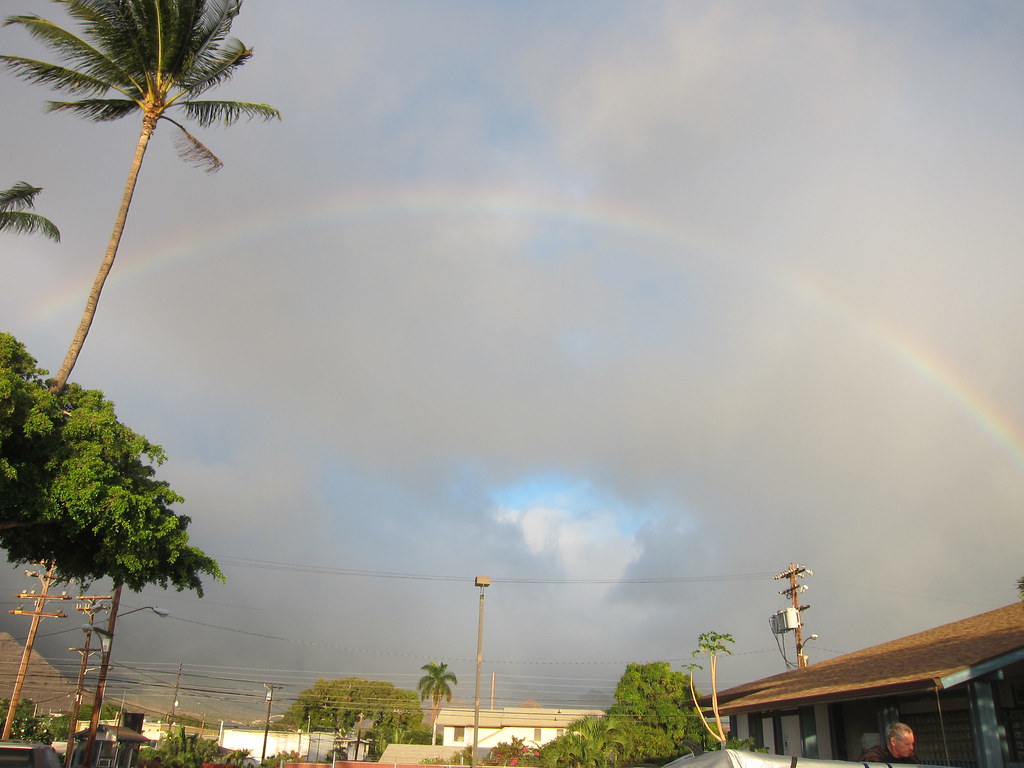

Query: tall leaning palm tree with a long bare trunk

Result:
[0,0,281,392]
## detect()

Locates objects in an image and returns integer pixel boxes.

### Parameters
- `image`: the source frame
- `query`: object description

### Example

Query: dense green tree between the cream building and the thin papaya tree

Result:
[608,662,702,763]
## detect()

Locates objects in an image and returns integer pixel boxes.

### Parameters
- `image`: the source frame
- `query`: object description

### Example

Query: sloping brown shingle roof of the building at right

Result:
[701,602,1024,715]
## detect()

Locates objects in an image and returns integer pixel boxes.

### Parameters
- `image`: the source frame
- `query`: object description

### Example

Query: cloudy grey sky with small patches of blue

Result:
[0,0,1024,719]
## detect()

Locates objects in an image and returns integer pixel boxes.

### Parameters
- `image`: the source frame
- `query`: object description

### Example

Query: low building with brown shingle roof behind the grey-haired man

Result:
[719,603,1024,768]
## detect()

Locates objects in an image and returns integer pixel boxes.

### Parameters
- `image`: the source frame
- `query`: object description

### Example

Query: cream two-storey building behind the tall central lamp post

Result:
[437,707,604,750]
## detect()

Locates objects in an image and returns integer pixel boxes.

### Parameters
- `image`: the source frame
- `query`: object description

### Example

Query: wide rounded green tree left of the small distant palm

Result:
[283,677,423,736]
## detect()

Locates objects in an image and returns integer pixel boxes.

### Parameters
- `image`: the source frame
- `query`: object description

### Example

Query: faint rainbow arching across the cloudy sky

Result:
[32,184,1024,472]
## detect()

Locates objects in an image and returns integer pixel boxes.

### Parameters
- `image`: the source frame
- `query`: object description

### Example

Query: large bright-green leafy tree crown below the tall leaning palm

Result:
[0,333,223,596]
